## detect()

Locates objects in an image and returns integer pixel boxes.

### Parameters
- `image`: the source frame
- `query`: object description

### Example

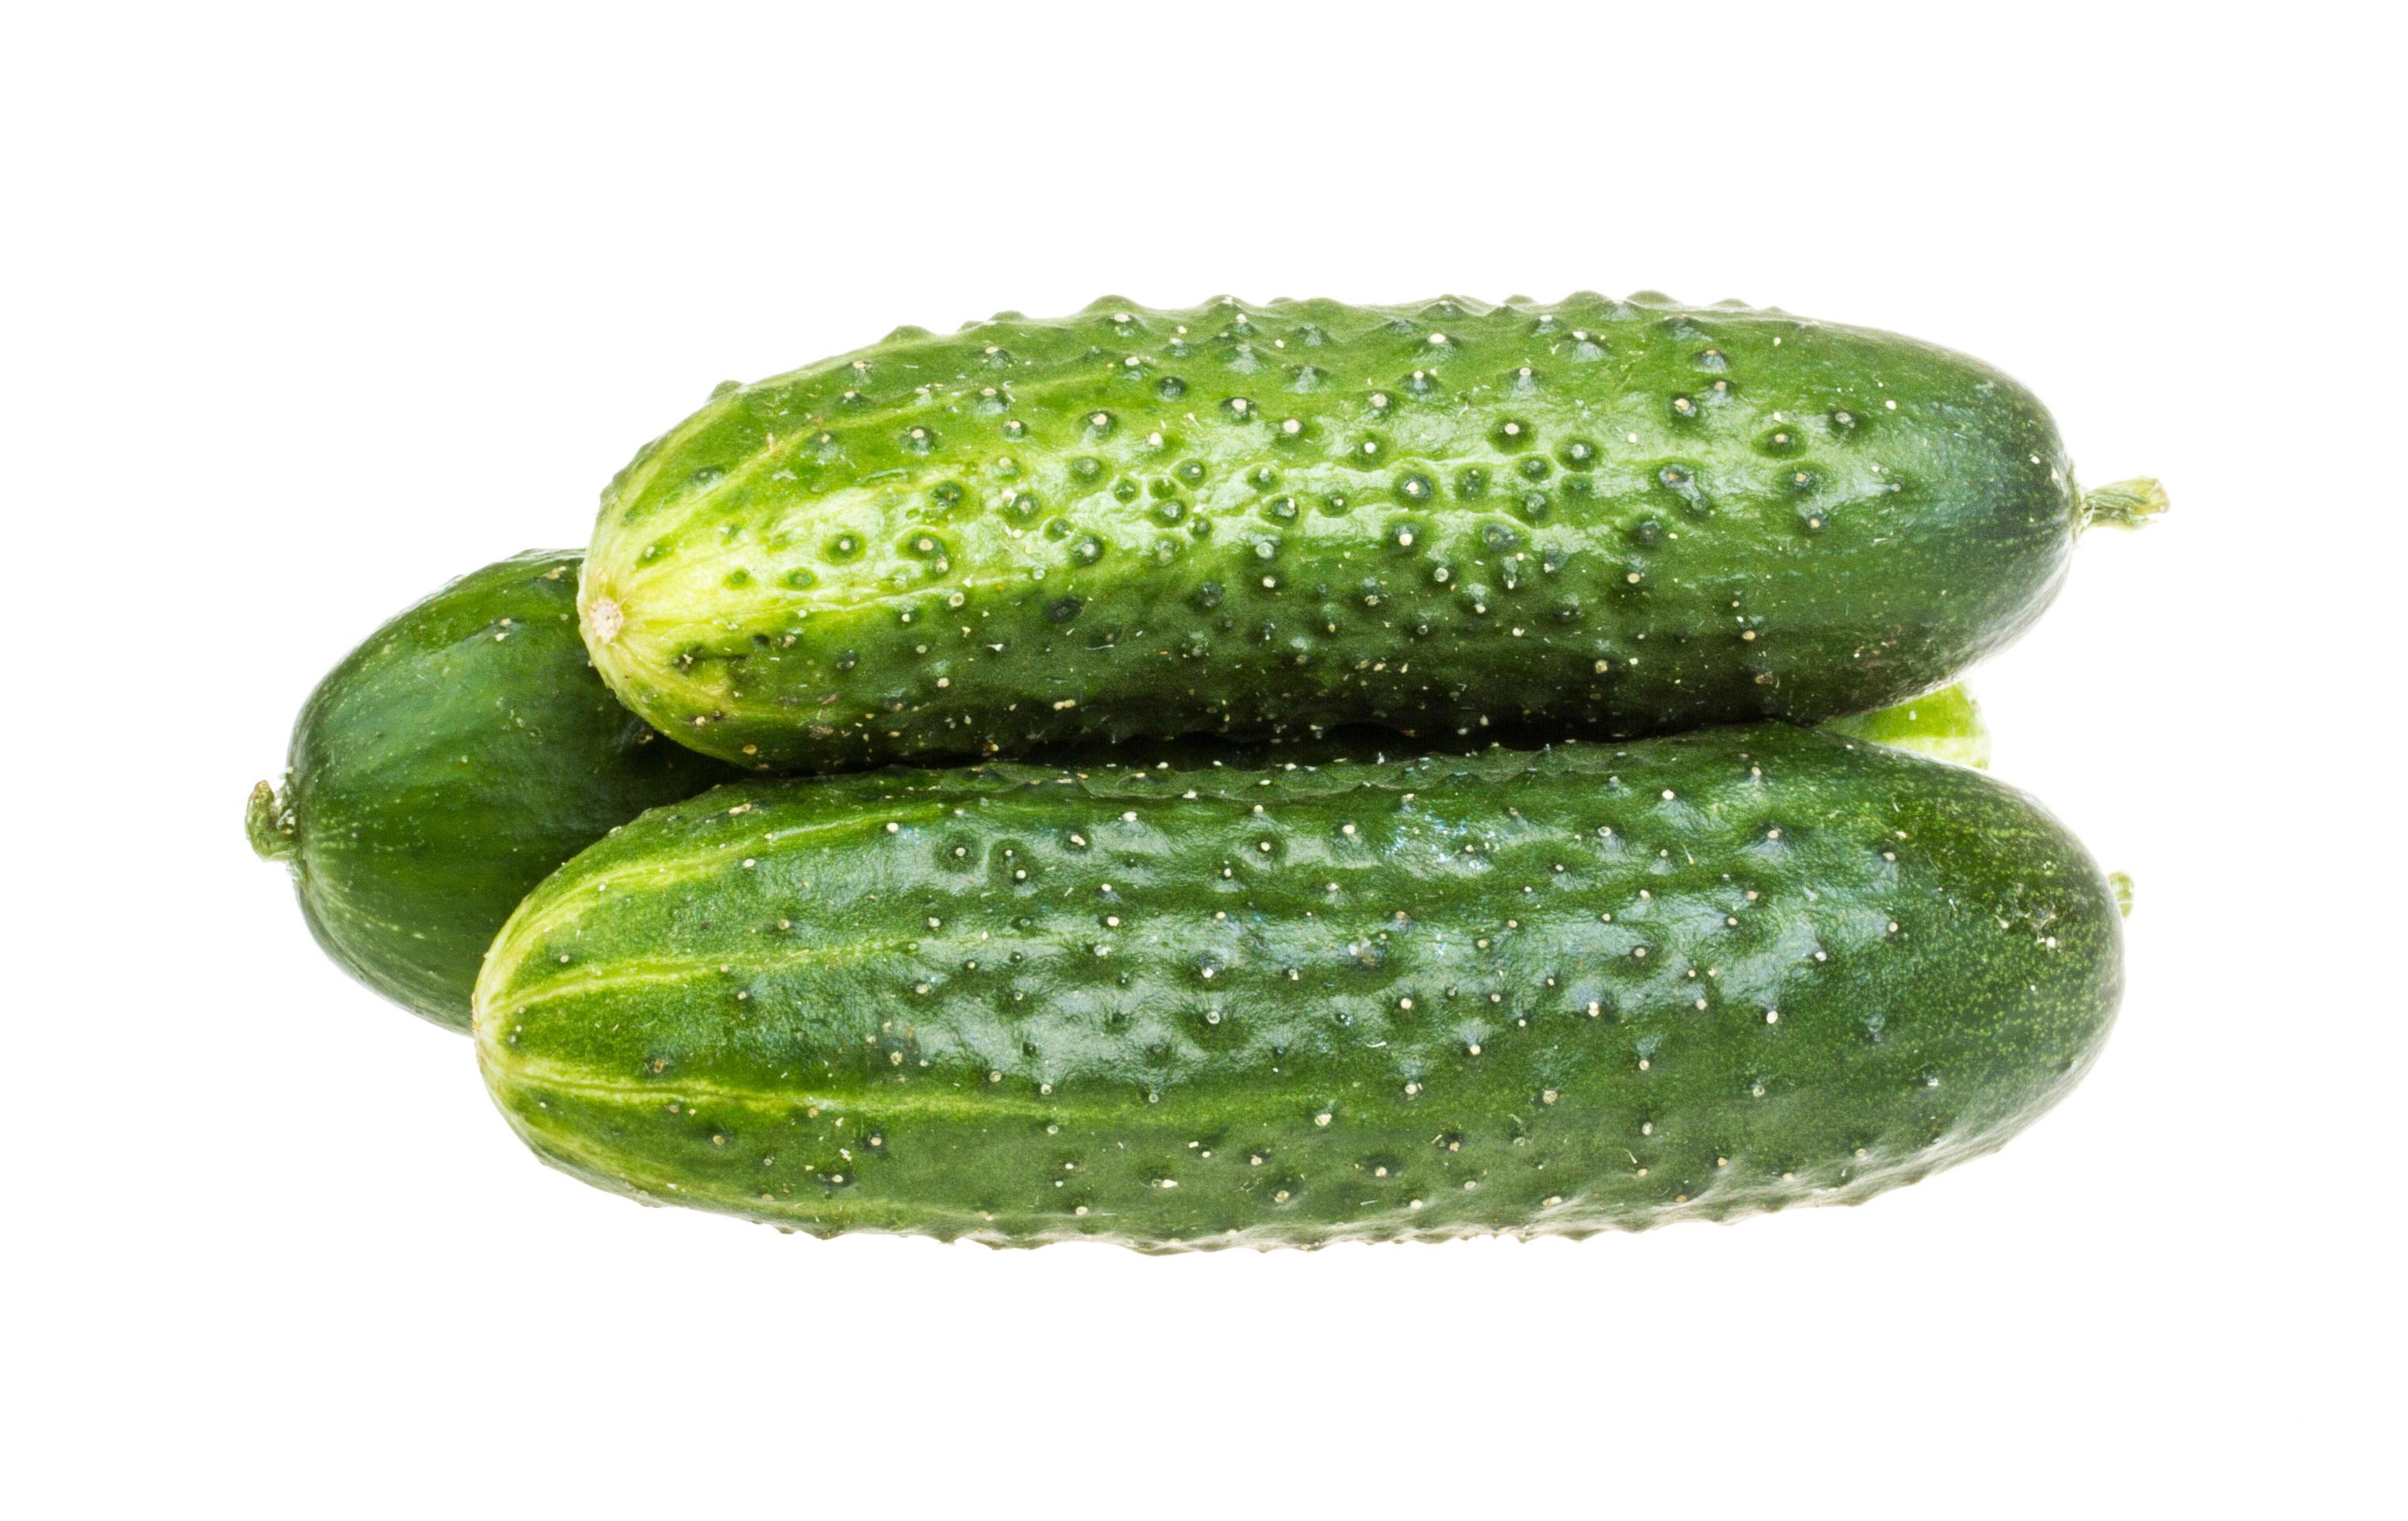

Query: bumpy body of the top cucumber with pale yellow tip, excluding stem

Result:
[580,294,2083,769]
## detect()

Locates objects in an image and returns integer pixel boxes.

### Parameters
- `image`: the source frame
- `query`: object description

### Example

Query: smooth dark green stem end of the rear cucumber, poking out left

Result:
[248,549,732,1029]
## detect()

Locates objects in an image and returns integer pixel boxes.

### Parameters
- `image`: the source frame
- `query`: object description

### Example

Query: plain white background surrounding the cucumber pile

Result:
[0,2,2408,1516]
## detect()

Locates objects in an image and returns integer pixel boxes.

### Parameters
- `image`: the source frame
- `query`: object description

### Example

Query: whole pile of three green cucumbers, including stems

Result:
[248,294,2164,1251]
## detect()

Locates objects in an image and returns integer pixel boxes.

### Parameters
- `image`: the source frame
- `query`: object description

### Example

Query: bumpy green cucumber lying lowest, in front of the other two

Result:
[477,726,2122,1251]
